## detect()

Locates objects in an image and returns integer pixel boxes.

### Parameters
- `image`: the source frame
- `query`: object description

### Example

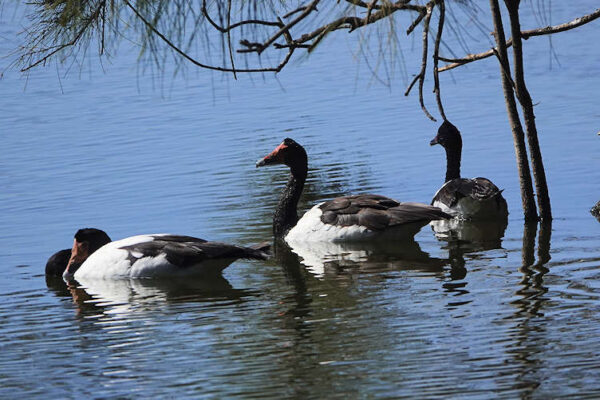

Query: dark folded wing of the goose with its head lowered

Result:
[121,235,267,268]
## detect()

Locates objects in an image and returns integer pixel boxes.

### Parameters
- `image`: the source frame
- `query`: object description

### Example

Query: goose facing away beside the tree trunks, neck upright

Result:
[429,121,508,220]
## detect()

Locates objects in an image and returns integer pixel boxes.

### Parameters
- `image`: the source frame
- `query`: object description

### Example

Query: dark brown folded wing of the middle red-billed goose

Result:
[319,194,450,231]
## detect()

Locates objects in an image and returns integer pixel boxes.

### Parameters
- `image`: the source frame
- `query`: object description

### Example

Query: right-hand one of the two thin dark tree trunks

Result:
[504,0,552,221]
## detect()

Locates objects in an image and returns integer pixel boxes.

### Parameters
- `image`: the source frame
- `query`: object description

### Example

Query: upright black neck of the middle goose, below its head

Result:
[273,163,308,237]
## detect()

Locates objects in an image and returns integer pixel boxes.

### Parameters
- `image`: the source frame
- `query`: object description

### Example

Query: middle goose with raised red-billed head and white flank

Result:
[256,138,451,243]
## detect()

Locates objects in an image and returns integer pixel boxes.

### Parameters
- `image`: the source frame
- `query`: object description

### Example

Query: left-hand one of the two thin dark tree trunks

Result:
[490,0,537,221]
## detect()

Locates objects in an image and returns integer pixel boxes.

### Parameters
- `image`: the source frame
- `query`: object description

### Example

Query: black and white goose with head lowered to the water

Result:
[63,228,269,279]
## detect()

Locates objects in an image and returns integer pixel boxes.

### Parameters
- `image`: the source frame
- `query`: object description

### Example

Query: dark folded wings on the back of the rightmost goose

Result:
[431,178,502,207]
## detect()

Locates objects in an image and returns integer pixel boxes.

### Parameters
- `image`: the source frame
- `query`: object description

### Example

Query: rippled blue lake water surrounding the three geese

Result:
[0,1,600,398]
